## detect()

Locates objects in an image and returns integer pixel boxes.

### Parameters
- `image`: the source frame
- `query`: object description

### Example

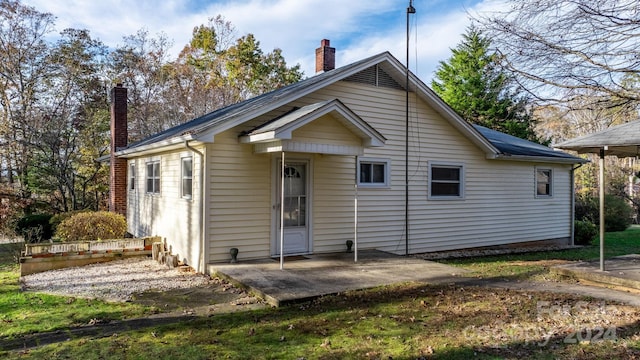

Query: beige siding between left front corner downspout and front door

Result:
[207,131,272,262]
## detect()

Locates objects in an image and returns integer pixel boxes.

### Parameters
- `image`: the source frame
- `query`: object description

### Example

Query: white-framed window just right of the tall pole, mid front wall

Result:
[429,162,464,199]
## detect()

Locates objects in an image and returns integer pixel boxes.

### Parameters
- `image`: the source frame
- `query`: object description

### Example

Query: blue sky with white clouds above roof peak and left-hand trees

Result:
[22,0,505,84]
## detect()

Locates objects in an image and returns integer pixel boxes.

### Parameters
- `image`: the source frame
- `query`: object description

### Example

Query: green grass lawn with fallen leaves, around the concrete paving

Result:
[0,228,640,360]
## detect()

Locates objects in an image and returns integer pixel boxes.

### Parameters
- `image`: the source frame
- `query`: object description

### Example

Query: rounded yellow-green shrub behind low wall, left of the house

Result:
[56,211,127,241]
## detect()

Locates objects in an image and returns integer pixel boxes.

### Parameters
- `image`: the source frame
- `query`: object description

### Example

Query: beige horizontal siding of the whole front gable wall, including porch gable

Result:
[207,82,571,262]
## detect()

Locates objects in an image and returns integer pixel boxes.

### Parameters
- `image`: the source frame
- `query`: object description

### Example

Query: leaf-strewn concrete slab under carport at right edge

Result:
[551,254,640,290]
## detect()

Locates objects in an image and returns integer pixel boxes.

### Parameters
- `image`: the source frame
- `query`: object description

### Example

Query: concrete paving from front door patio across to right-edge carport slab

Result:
[209,250,640,306]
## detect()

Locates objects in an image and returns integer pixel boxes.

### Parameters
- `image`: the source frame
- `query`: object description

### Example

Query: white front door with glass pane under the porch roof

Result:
[274,160,311,255]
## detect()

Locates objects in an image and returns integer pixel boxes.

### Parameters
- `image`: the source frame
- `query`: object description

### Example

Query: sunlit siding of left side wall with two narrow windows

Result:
[127,150,204,271]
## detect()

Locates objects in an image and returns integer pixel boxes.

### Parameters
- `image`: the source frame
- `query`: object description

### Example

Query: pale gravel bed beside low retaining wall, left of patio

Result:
[20,258,212,301]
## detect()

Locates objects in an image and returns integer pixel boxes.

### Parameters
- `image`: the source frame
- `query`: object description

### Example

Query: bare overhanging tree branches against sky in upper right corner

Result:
[475,0,640,109]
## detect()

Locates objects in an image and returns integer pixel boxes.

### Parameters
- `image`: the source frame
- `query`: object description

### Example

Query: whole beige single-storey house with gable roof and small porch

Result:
[112,40,583,272]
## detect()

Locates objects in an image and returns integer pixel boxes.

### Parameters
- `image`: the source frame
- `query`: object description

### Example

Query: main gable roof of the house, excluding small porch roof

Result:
[116,52,584,163]
